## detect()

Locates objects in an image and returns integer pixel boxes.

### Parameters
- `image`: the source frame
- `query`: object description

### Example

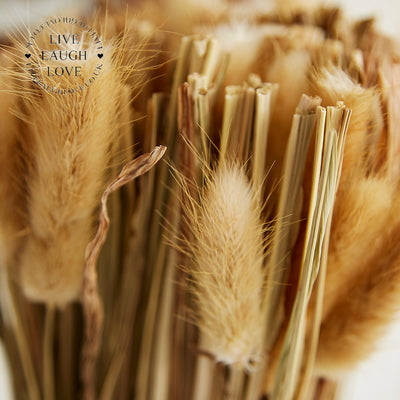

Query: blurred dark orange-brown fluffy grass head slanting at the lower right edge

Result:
[316,208,400,378]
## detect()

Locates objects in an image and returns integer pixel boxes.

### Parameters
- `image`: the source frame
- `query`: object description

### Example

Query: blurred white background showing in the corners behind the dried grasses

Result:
[0,0,400,400]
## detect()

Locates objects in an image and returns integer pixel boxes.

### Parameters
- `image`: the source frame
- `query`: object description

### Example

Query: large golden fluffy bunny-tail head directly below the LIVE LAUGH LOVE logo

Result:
[20,59,118,305]
